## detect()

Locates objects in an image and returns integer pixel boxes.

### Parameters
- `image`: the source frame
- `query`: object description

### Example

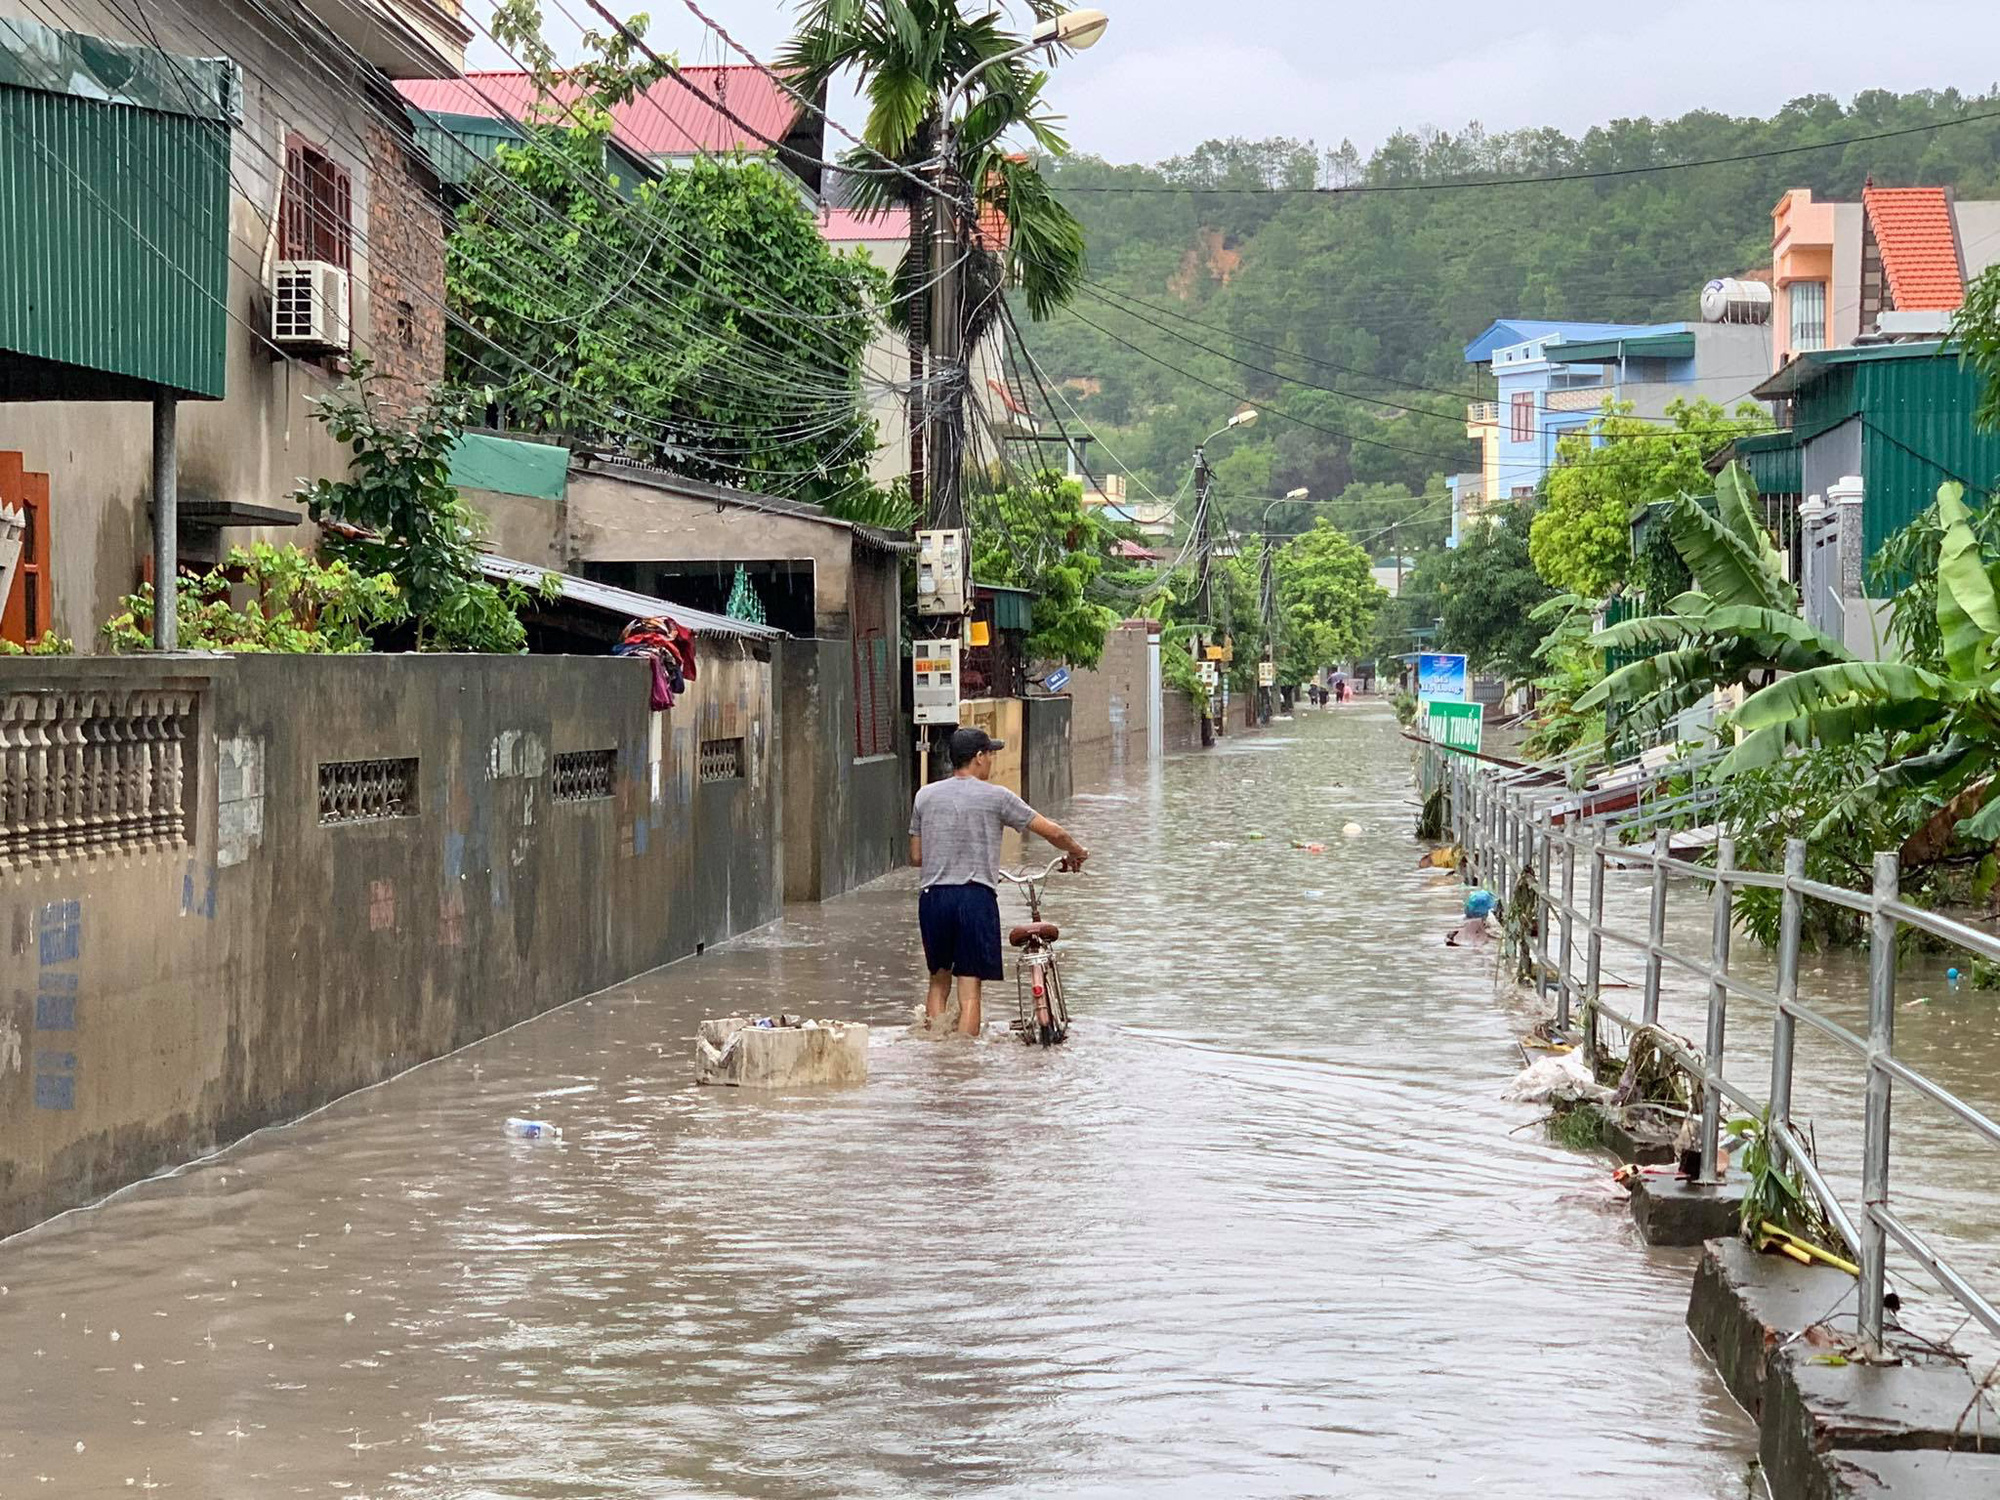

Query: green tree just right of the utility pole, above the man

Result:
[972,472,1118,668]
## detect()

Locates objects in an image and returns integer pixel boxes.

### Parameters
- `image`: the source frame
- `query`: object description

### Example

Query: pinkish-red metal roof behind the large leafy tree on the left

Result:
[396,68,800,156]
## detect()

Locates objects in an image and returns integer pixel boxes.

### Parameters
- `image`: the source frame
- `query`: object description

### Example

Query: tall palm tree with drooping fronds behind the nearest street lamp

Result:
[780,0,1084,506]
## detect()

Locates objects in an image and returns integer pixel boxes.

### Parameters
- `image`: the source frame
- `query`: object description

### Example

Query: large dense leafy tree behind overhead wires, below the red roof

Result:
[458,4,886,500]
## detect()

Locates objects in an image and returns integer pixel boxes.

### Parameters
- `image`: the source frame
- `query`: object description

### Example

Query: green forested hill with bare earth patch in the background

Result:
[1022,90,2000,550]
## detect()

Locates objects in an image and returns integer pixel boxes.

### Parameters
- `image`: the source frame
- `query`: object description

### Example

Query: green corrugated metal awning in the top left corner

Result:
[0,16,242,400]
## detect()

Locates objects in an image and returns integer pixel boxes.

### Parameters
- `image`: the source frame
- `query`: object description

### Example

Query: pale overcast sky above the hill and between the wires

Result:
[468,0,2000,162]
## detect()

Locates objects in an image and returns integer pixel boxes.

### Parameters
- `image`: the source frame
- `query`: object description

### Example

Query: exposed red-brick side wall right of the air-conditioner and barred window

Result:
[364,120,448,410]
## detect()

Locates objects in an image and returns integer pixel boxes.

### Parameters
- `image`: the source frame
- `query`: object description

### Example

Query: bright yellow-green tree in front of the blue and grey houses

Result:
[1528,400,1770,598]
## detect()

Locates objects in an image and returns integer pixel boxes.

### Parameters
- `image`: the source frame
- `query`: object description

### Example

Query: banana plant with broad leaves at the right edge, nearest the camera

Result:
[1718,484,2000,848]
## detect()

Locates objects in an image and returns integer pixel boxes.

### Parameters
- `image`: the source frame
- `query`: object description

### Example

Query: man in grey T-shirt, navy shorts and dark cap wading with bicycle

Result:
[910,728,1090,1036]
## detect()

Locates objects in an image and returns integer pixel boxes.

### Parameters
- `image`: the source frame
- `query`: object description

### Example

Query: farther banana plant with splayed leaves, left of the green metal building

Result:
[1574,464,1852,736]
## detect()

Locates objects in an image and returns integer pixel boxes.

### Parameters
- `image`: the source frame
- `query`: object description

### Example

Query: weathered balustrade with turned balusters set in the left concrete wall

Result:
[0,688,196,870]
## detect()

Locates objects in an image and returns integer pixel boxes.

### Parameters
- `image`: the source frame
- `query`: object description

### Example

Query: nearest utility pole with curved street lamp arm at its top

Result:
[912,10,1110,530]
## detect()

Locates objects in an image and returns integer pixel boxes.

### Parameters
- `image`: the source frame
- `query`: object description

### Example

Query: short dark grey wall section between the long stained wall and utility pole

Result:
[780,640,910,902]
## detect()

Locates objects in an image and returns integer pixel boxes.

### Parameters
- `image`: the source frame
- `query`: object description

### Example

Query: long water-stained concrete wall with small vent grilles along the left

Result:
[0,640,784,1234]
